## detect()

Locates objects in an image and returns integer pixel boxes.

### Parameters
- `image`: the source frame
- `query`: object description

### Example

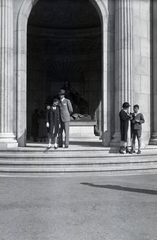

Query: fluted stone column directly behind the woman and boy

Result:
[110,0,133,147]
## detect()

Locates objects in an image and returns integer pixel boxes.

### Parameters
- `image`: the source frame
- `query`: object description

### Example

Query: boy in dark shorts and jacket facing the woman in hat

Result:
[131,104,145,154]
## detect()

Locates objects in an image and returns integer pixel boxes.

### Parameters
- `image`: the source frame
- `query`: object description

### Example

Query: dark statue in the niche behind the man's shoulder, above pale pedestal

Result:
[62,79,89,118]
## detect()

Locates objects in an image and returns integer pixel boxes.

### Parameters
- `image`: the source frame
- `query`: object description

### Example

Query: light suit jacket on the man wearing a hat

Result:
[59,98,73,122]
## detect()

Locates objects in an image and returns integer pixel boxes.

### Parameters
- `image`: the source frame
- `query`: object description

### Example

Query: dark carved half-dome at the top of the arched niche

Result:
[28,0,101,29]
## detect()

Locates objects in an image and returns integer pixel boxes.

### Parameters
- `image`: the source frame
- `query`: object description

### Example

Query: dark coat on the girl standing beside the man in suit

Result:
[46,106,61,136]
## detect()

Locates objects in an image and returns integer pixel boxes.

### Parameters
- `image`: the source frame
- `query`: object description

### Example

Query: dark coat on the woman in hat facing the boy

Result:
[119,109,131,142]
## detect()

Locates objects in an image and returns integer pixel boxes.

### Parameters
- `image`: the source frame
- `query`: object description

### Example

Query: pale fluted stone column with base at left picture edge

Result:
[0,0,17,148]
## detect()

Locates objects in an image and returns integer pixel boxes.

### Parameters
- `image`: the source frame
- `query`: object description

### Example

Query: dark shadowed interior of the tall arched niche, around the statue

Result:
[27,0,102,142]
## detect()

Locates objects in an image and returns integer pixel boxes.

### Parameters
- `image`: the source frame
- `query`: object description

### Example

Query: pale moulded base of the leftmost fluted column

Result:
[0,133,18,149]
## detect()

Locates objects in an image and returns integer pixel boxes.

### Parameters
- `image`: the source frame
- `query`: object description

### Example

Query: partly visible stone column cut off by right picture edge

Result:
[150,1,157,145]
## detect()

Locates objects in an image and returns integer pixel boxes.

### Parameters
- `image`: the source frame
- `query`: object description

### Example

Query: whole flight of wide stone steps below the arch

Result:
[0,143,157,174]
